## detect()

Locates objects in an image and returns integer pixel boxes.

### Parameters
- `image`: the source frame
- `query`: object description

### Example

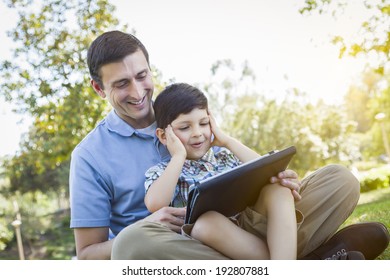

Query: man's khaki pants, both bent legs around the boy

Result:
[111,165,360,260]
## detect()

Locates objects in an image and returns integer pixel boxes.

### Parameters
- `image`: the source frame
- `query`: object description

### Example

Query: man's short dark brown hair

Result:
[87,30,149,88]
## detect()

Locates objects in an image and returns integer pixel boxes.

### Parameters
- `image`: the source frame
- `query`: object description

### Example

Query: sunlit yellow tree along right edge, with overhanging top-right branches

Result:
[300,0,390,162]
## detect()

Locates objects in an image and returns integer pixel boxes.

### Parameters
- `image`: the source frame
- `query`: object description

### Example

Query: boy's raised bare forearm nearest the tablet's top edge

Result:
[209,113,260,162]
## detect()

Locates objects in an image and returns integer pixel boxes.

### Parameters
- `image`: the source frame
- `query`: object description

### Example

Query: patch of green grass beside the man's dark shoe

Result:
[342,188,390,260]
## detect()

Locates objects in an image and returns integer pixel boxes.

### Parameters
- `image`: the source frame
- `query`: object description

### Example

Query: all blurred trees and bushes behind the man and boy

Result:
[0,0,390,259]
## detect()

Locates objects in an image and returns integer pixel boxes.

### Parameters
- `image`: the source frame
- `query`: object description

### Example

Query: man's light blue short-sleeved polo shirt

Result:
[69,110,170,235]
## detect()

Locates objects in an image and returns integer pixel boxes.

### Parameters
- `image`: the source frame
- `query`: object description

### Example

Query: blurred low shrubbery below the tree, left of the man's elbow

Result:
[0,190,75,260]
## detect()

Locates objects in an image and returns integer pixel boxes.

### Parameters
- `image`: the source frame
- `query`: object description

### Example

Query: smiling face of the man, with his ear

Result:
[92,50,154,128]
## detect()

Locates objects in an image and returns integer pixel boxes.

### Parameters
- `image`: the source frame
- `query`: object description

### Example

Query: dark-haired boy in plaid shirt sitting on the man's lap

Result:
[145,84,302,259]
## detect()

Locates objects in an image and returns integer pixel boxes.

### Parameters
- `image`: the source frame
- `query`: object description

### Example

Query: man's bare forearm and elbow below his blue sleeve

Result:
[74,227,113,260]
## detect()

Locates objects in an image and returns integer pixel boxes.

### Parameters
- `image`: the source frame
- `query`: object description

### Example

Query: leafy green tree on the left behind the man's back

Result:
[0,0,118,196]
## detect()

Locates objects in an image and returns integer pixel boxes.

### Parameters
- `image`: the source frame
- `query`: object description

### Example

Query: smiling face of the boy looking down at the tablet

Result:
[171,108,212,160]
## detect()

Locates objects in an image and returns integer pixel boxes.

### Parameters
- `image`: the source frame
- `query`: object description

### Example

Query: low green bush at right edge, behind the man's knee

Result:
[360,165,390,193]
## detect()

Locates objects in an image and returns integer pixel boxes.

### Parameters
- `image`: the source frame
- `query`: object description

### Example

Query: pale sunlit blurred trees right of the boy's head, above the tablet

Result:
[205,60,361,176]
